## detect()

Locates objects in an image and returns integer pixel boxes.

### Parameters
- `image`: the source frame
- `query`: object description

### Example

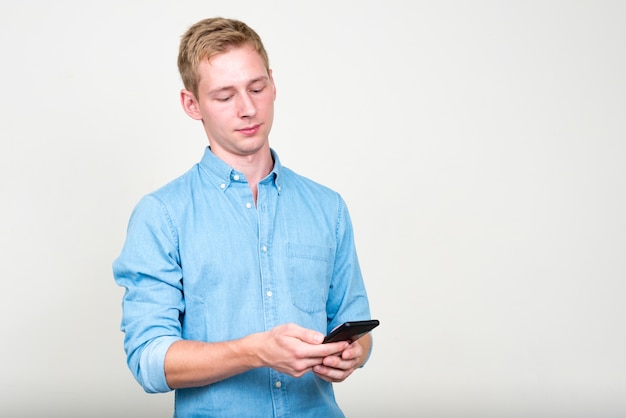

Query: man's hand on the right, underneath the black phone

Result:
[313,334,372,382]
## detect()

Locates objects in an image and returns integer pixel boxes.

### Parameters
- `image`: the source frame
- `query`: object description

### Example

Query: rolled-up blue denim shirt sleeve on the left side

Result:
[113,195,184,392]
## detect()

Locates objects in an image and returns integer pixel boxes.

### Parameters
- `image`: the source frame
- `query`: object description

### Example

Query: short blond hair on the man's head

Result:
[178,17,270,97]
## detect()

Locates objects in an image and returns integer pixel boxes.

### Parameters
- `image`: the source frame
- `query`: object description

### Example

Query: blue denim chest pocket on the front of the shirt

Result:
[287,243,332,313]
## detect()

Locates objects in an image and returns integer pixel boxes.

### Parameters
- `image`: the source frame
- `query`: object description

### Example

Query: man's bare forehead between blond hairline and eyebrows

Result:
[197,44,268,90]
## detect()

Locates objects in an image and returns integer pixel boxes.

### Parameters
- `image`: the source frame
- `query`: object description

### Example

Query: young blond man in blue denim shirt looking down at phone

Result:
[113,18,371,417]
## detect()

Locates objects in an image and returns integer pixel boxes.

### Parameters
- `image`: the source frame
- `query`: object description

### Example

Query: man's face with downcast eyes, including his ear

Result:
[182,45,276,162]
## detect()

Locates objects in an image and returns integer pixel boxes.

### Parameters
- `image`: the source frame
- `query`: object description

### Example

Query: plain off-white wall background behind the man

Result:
[0,0,626,418]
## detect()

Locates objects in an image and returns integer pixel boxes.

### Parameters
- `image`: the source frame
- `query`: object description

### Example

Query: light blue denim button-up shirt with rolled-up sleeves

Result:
[113,147,370,417]
